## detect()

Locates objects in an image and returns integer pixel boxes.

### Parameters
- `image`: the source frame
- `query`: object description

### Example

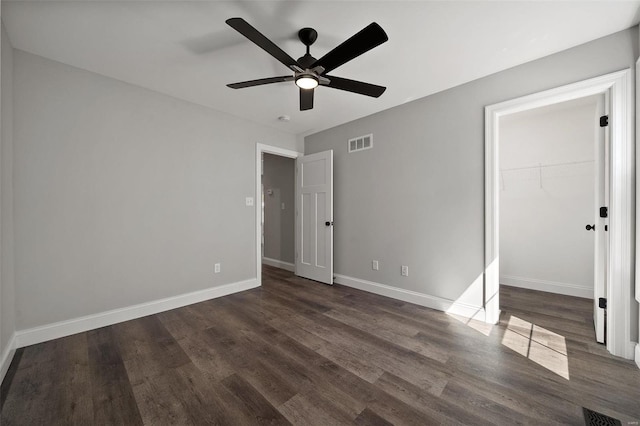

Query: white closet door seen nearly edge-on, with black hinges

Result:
[593,96,610,343]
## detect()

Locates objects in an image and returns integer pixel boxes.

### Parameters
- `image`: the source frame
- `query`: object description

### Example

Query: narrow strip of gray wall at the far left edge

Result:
[0,24,15,368]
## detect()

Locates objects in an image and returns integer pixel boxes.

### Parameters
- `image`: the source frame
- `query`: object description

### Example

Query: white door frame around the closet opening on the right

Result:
[484,69,635,359]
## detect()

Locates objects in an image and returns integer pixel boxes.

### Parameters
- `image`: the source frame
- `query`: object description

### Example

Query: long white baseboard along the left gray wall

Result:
[15,278,259,348]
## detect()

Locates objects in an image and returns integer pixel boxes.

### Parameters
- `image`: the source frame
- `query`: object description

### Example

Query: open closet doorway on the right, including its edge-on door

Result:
[498,95,608,343]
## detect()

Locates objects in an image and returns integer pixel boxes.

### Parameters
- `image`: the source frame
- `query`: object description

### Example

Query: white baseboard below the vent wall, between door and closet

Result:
[334,274,486,321]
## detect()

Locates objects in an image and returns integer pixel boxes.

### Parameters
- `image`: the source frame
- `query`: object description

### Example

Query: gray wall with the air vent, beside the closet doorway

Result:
[305,27,638,316]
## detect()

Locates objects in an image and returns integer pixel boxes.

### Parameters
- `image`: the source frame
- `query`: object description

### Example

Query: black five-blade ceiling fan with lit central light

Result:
[226,18,389,111]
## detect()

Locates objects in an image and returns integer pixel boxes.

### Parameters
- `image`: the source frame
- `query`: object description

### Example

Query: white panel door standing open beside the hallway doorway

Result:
[296,150,333,284]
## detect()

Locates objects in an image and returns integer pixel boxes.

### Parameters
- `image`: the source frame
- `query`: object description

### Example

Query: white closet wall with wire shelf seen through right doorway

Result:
[500,97,597,297]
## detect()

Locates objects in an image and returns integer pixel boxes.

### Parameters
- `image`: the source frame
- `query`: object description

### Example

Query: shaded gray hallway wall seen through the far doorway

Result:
[262,154,296,263]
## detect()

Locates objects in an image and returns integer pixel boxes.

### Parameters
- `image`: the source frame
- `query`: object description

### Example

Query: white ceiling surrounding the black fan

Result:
[2,0,640,134]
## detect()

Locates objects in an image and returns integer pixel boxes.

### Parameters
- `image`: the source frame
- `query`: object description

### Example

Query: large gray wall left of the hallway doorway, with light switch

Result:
[14,50,296,330]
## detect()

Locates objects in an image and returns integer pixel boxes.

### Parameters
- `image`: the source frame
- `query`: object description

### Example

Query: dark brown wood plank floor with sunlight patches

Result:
[0,267,640,426]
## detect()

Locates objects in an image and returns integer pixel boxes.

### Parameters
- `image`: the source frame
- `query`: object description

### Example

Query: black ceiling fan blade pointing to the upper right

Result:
[309,22,389,72]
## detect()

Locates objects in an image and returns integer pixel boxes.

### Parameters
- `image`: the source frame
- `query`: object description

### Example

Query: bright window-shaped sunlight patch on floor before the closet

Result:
[502,316,569,380]
